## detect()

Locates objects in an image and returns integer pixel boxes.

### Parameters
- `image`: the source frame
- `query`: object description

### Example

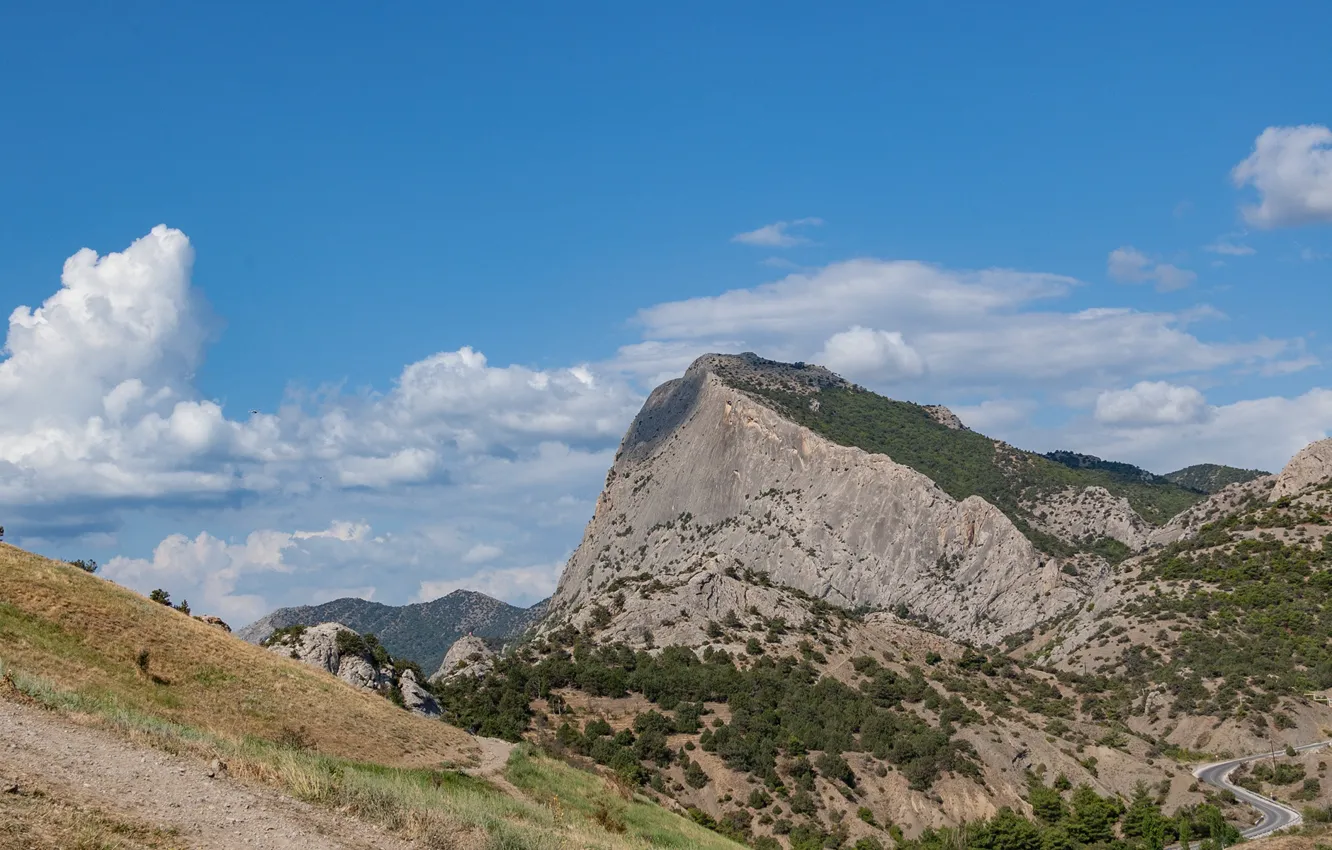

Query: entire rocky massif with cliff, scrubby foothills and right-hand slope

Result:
[432,354,1332,850]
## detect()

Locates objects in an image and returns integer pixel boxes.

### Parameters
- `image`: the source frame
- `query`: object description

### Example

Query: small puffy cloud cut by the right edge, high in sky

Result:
[1231,124,1332,228]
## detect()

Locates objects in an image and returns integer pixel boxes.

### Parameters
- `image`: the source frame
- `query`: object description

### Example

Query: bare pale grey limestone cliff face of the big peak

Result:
[545,354,1084,645]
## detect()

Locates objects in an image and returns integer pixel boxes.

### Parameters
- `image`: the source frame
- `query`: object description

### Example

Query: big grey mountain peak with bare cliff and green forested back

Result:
[543,354,1200,645]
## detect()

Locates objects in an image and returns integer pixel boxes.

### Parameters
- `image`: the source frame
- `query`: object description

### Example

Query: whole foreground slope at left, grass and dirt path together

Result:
[0,545,737,850]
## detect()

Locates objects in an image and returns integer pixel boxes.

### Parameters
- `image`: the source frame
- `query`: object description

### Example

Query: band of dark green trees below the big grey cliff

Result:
[436,645,976,789]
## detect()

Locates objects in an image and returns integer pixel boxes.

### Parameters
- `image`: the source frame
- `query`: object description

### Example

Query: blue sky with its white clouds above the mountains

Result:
[0,3,1332,621]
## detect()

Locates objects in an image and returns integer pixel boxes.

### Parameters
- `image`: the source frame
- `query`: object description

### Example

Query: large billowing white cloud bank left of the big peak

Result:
[0,226,639,529]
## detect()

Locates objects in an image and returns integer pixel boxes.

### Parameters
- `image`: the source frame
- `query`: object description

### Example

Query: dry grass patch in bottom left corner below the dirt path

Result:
[0,786,188,850]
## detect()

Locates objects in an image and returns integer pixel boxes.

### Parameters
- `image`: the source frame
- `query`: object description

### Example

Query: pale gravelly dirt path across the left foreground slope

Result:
[0,699,413,850]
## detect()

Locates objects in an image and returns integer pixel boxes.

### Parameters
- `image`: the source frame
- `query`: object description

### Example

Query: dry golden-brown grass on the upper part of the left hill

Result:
[0,544,476,767]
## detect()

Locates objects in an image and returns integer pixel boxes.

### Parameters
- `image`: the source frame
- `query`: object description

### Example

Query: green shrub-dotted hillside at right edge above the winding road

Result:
[1038,484,1332,735]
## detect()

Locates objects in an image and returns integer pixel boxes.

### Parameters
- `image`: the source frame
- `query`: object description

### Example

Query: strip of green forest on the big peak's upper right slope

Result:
[737,381,1201,553]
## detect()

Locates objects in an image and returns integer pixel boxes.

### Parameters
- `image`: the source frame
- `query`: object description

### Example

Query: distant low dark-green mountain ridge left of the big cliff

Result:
[237,590,546,670]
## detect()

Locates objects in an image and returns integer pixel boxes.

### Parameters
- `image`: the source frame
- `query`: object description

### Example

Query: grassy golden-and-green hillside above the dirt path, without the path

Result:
[0,544,738,850]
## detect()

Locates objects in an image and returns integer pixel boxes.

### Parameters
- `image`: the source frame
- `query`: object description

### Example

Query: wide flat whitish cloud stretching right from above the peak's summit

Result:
[615,260,1305,398]
